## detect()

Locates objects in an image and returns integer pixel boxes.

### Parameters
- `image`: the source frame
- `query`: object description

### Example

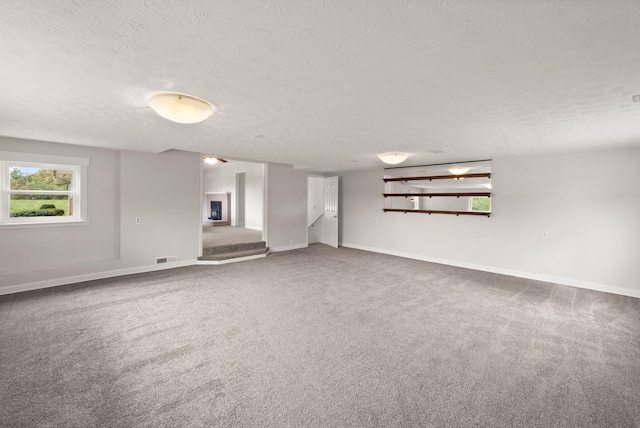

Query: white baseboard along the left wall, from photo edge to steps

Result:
[0,260,196,295]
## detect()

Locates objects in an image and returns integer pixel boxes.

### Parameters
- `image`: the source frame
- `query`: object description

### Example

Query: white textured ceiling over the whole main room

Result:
[0,0,640,171]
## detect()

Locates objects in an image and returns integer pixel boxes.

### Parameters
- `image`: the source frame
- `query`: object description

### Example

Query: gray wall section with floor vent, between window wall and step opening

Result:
[120,150,202,266]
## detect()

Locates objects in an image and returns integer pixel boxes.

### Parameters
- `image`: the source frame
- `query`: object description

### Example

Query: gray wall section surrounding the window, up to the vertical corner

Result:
[0,137,120,294]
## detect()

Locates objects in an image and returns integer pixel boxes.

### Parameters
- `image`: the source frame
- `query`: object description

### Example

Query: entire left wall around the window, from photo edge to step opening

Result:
[0,137,202,294]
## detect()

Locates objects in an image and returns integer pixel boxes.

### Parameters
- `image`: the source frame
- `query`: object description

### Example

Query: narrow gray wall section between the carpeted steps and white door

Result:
[265,163,307,251]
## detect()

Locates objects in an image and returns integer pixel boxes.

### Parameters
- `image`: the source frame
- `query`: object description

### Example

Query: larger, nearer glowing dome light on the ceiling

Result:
[149,93,215,123]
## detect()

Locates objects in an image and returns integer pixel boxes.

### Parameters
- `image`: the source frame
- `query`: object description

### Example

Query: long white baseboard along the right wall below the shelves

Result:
[340,242,640,298]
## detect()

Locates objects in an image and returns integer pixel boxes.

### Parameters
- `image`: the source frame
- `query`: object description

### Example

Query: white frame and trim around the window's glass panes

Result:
[0,152,89,227]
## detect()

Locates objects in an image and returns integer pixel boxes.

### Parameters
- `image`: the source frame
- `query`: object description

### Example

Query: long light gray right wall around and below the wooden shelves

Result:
[340,149,640,297]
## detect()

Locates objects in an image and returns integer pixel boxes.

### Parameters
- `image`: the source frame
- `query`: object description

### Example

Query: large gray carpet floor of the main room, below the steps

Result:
[0,245,640,427]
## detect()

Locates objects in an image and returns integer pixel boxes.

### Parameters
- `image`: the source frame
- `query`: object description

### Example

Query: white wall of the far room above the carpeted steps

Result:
[203,162,264,230]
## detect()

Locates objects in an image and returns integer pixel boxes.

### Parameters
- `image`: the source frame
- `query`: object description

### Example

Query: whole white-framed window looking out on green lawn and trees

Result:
[0,152,88,225]
